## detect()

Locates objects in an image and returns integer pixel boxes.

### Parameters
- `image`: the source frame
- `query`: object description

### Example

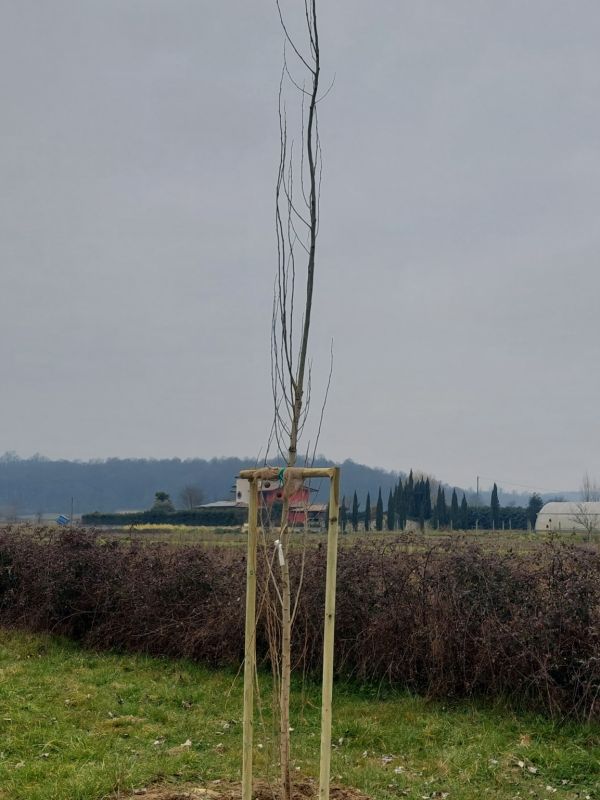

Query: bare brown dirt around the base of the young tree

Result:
[119,779,370,800]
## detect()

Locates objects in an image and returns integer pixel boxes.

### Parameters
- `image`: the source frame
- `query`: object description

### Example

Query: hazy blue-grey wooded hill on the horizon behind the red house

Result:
[0,453,406,518]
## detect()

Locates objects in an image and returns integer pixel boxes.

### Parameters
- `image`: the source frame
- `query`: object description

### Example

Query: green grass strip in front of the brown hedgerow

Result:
[0,630,600,800]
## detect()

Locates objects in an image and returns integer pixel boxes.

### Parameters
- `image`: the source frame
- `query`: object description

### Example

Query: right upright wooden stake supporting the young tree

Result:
[319,467,340,800]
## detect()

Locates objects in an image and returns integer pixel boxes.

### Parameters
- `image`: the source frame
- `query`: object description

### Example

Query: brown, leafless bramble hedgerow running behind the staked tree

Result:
[0,528,600,718]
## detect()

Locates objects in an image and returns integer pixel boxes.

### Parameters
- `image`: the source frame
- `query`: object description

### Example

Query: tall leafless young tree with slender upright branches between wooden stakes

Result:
[270,0,331,800]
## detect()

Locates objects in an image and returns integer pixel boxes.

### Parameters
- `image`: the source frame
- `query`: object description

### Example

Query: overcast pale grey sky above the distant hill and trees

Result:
[0,0,600,490]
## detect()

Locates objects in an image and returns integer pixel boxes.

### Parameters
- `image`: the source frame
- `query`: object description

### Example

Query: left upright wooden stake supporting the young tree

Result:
[242,477,258,800]
